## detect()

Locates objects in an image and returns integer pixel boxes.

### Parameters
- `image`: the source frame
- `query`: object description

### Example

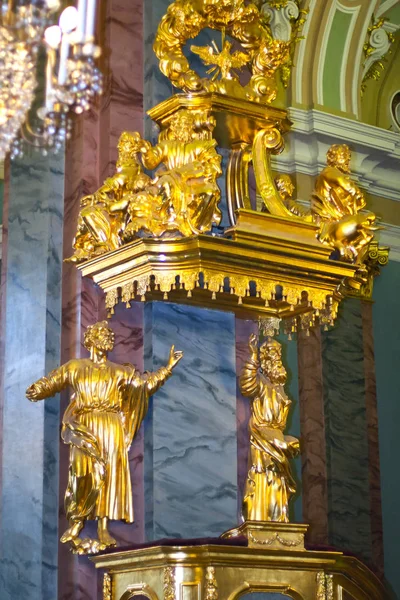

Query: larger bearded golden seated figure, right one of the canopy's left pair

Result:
[125,109,222,239]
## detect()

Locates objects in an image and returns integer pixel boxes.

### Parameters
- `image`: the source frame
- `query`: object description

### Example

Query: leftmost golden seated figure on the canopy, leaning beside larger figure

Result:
[67,131,150,262]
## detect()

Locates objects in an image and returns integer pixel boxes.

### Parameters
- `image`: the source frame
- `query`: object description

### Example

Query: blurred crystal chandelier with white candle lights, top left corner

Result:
[0,0,102,160]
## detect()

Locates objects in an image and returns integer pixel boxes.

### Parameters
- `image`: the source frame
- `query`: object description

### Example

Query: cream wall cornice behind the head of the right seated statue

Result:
[272,107,400,201]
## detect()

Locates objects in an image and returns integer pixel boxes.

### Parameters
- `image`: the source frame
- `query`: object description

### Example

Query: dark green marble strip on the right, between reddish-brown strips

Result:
[322,299,372,561]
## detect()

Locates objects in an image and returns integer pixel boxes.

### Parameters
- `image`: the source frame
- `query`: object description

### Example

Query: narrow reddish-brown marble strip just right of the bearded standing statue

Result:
[297,328,329,545]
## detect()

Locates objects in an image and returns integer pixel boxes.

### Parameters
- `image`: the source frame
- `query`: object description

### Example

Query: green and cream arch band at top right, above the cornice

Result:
[291,0,386,117]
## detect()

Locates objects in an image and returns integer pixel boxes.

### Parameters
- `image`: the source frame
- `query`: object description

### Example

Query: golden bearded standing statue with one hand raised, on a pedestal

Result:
[240,335,300,523]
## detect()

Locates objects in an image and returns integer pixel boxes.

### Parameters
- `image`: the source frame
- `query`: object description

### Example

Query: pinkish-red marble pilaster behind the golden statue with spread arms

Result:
[58,0,144,600]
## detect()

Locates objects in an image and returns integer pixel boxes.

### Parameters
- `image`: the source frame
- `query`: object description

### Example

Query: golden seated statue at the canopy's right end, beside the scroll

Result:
[311,144,379,263]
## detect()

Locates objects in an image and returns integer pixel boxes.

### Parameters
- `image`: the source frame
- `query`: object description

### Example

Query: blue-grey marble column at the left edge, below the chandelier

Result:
[0,151,64,600]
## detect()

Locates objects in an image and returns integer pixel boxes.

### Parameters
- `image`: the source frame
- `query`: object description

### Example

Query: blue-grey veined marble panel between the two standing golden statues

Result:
[144,302,237,539]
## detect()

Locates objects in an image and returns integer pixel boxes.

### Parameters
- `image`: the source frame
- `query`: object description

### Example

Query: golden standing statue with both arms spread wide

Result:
[26,321,182,554]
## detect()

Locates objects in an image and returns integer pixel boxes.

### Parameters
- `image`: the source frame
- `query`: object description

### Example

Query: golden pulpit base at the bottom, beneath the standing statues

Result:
[92,526,388,600]
